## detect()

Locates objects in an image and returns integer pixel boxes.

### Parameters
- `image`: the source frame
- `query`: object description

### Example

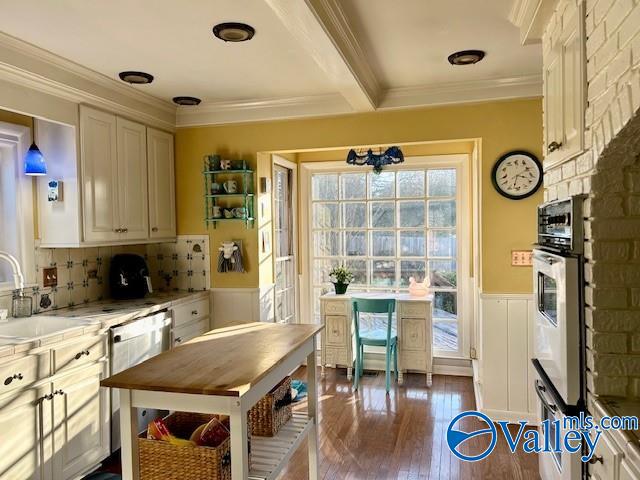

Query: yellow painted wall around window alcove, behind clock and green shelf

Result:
[176,99,542,293]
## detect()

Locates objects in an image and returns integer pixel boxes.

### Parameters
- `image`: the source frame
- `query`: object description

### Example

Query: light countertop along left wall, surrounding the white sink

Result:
[0,291,209,357]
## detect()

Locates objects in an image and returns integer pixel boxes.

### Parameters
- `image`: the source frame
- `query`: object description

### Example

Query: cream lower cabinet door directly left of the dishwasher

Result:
[53,362,110,479]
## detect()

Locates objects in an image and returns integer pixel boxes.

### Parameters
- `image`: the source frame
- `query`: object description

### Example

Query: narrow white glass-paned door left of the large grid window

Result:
[273,156,298,323]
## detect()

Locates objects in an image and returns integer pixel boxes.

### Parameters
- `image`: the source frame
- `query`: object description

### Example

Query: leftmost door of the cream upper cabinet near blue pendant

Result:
[79,107,120,242]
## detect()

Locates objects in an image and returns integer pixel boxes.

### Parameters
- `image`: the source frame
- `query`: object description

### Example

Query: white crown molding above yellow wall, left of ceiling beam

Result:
[176,93,353,128]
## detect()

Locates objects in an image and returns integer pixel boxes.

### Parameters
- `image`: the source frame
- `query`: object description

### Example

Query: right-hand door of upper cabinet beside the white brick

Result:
[559,5,585,160]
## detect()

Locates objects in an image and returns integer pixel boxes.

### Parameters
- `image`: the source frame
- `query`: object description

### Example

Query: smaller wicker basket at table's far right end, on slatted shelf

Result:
[249,377,291,437]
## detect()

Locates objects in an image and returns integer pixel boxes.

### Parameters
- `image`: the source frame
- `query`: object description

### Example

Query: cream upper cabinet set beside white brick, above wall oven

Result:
[544,2,586,165]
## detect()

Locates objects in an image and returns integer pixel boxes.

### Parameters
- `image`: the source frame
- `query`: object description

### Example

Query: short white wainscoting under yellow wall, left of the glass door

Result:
[211,284,275,328]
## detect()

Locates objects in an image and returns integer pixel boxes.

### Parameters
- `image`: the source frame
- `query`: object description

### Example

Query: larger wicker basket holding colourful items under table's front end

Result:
[138,412,231,480]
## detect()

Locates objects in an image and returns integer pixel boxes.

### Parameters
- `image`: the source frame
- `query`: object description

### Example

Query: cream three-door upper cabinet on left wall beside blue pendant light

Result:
[38,105,176,247]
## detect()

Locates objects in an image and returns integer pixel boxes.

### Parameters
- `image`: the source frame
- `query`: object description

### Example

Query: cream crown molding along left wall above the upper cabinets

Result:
[0,32,176,130]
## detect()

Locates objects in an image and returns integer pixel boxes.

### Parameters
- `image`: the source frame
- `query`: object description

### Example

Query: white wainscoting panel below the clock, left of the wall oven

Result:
[473,294,538,423]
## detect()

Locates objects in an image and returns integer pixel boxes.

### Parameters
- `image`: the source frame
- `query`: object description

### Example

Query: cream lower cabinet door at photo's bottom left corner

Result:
[0,384,52,480]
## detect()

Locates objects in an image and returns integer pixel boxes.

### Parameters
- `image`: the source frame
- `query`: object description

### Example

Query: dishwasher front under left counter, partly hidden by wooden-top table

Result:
[109,310,171,453]
